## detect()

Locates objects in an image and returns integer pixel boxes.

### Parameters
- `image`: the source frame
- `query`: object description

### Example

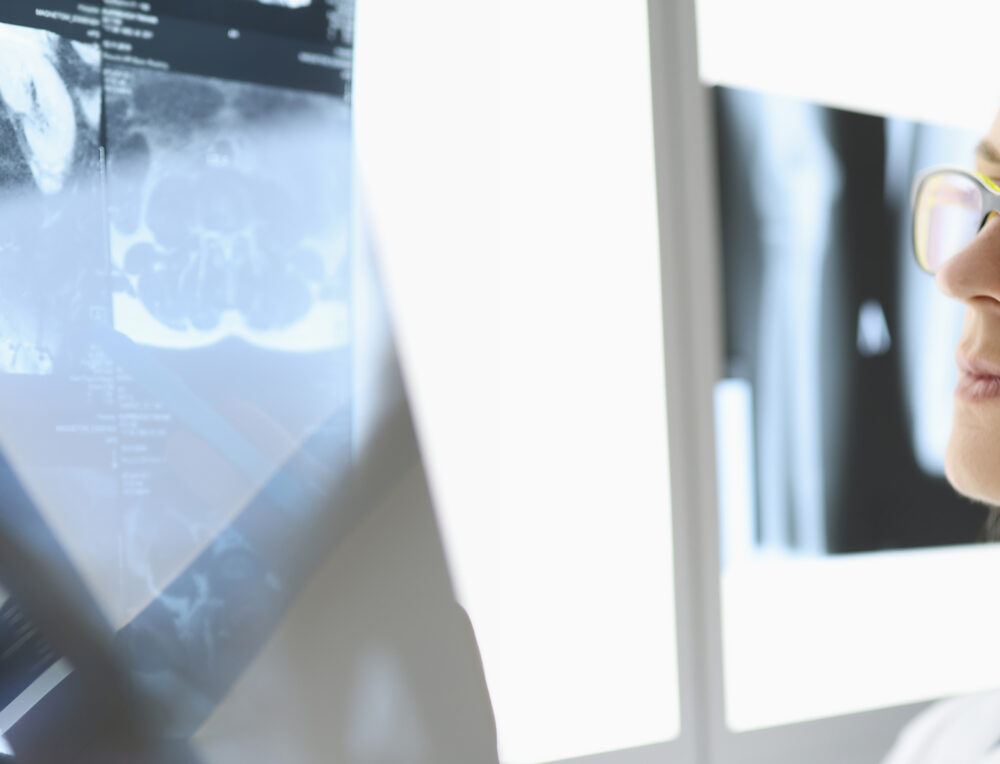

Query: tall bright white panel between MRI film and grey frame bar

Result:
[354,0,679,764]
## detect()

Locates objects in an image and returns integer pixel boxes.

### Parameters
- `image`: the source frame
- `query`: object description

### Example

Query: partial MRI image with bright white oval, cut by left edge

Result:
[0,24,104,375]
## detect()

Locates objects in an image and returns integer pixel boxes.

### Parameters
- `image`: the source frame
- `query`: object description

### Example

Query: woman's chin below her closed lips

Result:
[945,400,1000,504]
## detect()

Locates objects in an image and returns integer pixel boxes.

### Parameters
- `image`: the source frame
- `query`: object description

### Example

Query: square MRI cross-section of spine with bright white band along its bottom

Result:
[106,65,350,351]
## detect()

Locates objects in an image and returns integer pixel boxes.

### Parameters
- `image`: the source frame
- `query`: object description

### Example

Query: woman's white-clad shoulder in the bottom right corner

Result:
[882,690,1000,764]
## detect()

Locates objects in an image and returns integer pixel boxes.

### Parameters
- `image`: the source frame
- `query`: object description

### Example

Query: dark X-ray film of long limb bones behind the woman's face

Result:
[714,88,985,556]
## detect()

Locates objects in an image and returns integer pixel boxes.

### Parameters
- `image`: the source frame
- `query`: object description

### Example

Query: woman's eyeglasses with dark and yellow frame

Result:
[911,167,1000,274]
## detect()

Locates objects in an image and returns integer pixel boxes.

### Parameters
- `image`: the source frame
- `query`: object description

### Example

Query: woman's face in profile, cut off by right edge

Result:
[936,109,1000,504]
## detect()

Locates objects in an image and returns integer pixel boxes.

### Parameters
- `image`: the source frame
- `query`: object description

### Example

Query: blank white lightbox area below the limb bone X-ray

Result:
[722,546,1000,731]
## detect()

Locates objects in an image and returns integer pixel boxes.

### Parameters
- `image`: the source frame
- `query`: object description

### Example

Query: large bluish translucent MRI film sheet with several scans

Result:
[0,0,364,762]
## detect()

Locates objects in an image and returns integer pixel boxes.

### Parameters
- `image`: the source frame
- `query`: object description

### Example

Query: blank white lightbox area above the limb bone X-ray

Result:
[697,0,1000,131]
